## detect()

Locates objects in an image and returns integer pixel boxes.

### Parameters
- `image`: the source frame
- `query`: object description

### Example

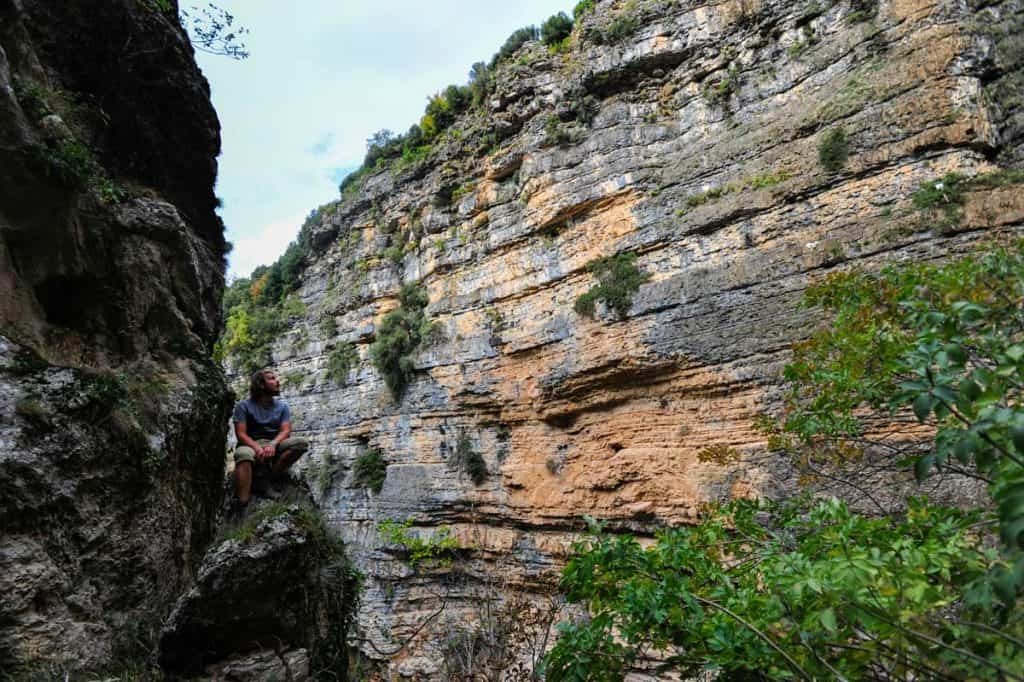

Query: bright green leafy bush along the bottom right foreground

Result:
[547,500,1024,682]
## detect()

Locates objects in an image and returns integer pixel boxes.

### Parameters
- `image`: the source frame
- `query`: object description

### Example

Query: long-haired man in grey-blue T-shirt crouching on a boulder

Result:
[231,370,309,516]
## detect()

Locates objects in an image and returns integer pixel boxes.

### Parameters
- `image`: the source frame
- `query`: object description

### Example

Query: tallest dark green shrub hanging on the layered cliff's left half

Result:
[370,284,435,400]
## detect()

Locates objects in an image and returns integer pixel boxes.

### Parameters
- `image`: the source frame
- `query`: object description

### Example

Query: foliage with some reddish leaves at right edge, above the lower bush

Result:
[779,243,1024,565]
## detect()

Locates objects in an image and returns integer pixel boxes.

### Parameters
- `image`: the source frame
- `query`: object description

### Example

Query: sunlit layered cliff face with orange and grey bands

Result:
[245,0,1024,677]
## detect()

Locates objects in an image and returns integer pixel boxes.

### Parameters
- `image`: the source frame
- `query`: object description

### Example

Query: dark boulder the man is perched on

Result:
[159,503,353,682]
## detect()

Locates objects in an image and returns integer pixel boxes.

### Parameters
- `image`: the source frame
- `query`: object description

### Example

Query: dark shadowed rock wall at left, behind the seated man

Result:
[0,0,227,675]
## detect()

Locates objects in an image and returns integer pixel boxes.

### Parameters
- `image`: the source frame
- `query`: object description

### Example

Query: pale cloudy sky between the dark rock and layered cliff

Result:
[194,0,574,276]
